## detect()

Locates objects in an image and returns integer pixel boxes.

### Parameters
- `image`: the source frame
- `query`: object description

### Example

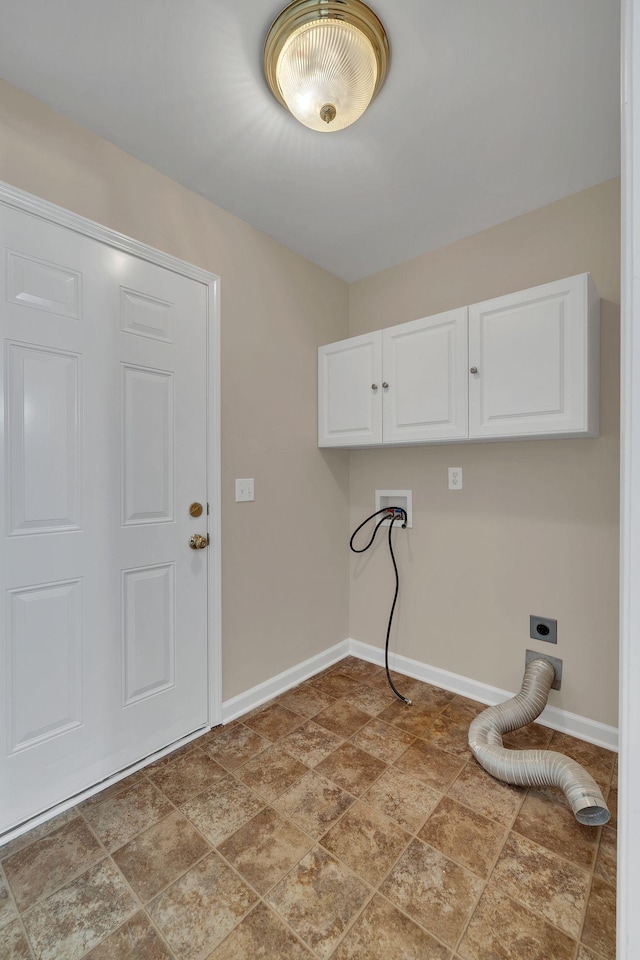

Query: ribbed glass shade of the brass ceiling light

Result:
[276,19,378,133]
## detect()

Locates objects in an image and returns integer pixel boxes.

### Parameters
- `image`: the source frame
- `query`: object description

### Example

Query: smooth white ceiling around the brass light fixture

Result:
[0,0,620,281]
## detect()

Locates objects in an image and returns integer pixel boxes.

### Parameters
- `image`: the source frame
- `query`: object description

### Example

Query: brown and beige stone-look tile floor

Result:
[0,657,617,960]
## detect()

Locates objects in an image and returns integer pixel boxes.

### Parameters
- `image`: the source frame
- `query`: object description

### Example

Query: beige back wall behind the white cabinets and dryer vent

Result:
[349,180,620,725]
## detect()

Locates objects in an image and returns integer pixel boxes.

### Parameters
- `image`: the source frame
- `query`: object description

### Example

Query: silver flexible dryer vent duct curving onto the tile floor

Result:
[469,660,610,827]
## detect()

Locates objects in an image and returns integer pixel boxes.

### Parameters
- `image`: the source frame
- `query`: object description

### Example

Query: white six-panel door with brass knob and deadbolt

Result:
[0,207,207,830]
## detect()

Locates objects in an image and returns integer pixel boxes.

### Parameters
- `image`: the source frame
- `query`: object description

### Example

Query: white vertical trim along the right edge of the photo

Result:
[617,0,640,960]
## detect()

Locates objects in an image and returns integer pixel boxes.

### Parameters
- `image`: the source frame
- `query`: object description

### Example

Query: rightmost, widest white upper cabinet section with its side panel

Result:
[469,274,599,439]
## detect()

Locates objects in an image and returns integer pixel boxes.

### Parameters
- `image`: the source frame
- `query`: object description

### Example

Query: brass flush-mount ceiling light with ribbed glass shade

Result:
[264,0,389,133]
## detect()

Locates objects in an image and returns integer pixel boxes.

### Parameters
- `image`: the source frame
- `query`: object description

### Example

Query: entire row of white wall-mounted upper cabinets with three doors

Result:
[318,273,600,447]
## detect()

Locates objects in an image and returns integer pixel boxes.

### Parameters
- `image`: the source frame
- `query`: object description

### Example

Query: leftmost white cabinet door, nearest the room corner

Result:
[318,330,382,447]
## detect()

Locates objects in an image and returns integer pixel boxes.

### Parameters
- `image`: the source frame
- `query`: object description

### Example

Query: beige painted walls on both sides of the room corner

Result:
[0,82,619,724]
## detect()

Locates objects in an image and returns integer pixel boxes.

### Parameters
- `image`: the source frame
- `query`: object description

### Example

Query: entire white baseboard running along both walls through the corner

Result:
[222,639,618,750]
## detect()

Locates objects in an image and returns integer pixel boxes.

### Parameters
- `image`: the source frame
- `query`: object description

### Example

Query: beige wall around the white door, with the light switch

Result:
[0,82,348,699]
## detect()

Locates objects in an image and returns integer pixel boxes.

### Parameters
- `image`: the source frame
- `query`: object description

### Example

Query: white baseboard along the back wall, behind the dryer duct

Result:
[348,639,618,751]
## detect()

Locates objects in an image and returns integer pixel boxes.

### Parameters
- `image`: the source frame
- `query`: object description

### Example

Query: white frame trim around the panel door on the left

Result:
[0,181,222,726]
